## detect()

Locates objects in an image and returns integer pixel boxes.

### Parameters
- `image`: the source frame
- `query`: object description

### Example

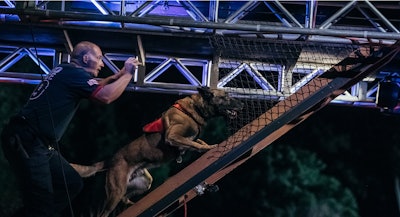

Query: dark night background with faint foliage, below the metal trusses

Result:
[0,84,400,217]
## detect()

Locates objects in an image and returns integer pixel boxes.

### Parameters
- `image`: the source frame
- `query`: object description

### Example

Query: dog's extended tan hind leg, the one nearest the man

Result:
[99,161,132,217]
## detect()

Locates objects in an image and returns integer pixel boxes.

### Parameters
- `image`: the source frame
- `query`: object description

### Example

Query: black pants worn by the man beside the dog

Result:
[1,119,83,217]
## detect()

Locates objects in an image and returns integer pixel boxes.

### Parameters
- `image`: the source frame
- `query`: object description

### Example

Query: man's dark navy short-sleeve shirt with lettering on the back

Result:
[20,64,101,141]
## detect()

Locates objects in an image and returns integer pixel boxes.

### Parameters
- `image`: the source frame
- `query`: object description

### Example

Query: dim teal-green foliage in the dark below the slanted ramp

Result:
[185,145,358,217]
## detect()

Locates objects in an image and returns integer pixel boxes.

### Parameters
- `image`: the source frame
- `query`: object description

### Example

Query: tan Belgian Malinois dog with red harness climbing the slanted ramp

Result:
[99,87,243,217]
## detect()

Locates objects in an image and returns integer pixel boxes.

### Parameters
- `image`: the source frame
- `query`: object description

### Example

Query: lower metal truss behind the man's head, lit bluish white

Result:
[0,43,377,103]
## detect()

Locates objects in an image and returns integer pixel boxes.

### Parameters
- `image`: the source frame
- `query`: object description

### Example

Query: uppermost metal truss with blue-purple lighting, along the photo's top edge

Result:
[0,0,399,38]
